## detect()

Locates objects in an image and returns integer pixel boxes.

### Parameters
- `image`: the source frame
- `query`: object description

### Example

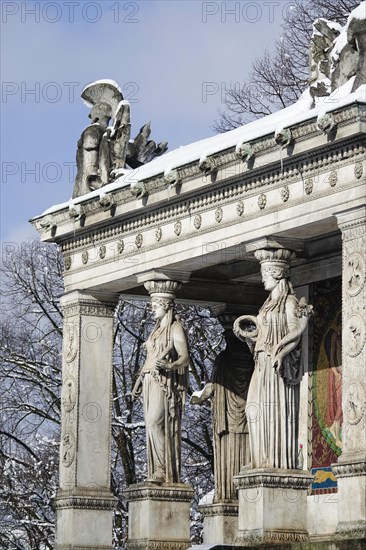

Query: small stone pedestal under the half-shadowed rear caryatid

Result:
[198,501,239,544]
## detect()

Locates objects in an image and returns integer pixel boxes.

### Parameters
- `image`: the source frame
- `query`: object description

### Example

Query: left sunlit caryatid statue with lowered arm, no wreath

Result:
[132,281,189,483]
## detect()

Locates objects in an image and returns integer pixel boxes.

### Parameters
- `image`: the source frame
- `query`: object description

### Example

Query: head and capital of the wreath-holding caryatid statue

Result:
[254,248,295,291]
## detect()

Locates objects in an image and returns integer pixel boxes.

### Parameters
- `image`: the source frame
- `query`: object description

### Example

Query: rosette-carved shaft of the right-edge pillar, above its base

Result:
[337,208,366,454]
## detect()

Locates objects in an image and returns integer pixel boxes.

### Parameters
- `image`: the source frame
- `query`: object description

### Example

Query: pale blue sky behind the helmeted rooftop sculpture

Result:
[1,0,291,243]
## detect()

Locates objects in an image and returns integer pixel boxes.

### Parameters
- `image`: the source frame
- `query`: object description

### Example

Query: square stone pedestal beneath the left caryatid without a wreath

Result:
[126,481,194,550]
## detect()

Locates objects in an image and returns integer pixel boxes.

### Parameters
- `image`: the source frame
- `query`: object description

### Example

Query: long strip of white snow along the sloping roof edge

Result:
[36,82,366,217]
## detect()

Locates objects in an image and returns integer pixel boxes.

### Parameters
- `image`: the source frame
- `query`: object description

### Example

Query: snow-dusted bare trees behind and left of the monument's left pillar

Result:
[0,243,223,550]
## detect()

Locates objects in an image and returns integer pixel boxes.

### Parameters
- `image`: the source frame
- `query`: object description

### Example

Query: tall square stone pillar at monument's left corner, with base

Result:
[55,291,117,550]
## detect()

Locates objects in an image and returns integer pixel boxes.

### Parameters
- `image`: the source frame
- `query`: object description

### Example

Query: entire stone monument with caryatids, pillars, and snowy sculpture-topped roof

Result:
[32,1,366,550]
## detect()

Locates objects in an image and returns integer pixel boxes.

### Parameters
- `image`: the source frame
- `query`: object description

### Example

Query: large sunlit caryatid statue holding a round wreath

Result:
[233,248,312,469]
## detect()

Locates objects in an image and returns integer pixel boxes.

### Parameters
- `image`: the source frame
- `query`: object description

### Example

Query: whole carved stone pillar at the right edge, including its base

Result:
[332,206,366,539]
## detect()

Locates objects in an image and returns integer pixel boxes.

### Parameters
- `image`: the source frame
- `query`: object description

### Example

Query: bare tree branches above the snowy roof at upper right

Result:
[213,0,360,132]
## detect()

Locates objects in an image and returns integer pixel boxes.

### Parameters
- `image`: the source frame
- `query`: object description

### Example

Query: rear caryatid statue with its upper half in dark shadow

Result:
[190,315,253,503]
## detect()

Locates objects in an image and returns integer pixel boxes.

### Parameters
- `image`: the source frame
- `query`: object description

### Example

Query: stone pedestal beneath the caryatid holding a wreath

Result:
[235,468,312,546]
